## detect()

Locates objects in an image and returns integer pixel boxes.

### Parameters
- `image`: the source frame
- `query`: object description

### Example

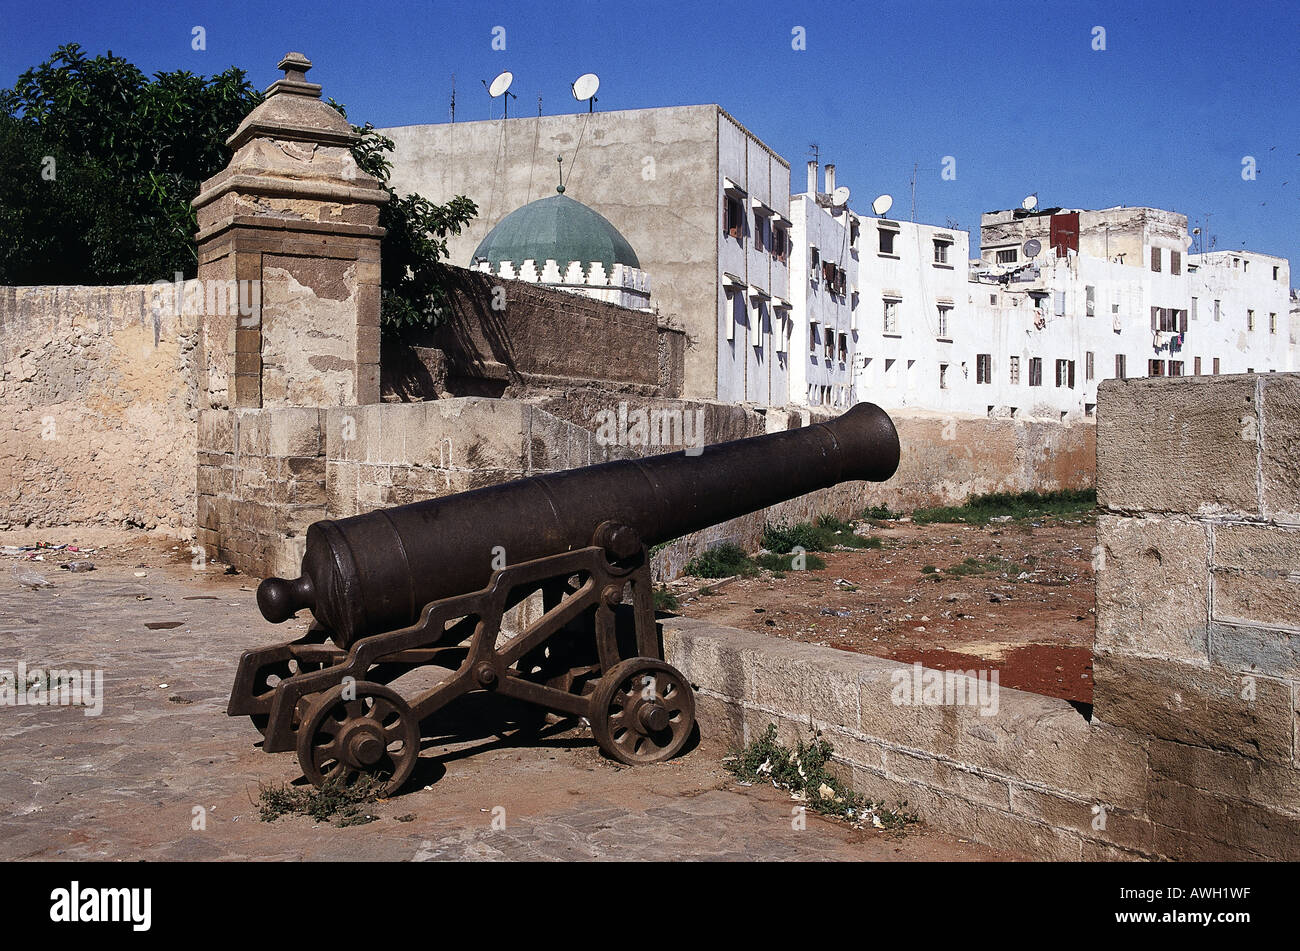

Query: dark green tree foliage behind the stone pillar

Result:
[0,44,477,326]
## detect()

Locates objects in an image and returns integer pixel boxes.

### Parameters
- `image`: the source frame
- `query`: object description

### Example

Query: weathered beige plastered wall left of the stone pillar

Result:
[0,285,202,537]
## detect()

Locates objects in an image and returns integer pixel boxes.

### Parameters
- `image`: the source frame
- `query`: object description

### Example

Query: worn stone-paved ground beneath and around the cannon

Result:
[0,535,1018,861]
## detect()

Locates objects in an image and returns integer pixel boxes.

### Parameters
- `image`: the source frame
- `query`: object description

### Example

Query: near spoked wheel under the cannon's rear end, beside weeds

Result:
[298,681,420,796]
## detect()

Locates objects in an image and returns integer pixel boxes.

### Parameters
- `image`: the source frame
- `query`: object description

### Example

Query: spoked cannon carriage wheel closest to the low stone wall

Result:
[590,657,696,765]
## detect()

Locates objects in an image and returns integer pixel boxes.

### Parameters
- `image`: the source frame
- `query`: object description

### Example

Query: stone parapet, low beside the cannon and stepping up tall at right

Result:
[664,374,1300,860]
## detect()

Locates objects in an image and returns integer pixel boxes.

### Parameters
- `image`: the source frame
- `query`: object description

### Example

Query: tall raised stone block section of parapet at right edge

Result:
[1093,373,1300,859]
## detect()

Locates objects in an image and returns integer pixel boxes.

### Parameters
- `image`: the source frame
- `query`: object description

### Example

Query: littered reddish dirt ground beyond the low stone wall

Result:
[671,517,1097,703]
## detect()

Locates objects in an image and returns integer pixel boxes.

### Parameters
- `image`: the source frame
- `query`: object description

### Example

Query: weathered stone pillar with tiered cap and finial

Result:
[194,53,387,409]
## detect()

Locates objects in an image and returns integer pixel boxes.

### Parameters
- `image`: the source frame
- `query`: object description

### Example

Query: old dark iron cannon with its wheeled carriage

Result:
[228,403,900,795]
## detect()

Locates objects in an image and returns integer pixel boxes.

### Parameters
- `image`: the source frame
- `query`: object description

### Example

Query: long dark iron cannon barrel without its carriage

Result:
[257,403,898,647]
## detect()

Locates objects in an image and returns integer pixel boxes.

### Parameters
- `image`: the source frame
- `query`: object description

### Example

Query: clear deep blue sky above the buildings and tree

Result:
[0,0,1300,271]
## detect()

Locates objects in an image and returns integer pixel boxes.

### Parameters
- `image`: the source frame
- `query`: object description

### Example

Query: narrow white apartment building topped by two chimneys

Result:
[789,161,862,408]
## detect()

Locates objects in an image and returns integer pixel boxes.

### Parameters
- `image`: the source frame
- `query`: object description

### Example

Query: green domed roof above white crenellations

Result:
[471,195,641,272]
